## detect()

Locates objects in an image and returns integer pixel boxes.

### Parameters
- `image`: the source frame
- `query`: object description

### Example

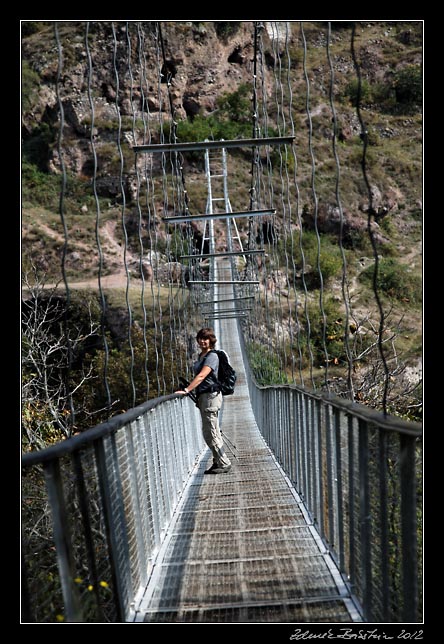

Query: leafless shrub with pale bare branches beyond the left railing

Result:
[22,267,99,449]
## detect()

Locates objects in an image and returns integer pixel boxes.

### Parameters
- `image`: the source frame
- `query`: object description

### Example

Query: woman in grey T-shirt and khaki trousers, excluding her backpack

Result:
[175,328,231,474]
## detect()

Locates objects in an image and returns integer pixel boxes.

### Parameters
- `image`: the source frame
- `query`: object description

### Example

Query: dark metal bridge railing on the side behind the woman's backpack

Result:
[245,354,422,622]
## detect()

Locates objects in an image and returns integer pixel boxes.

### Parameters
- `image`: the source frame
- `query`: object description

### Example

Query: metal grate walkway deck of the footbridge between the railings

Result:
[136,312,360,623]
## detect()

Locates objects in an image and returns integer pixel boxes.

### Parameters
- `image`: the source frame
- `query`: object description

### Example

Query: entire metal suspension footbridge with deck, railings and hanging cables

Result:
[21,23,422,624]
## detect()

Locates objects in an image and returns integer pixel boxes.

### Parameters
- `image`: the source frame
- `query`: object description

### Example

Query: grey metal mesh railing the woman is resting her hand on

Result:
[22,395,204,623]
